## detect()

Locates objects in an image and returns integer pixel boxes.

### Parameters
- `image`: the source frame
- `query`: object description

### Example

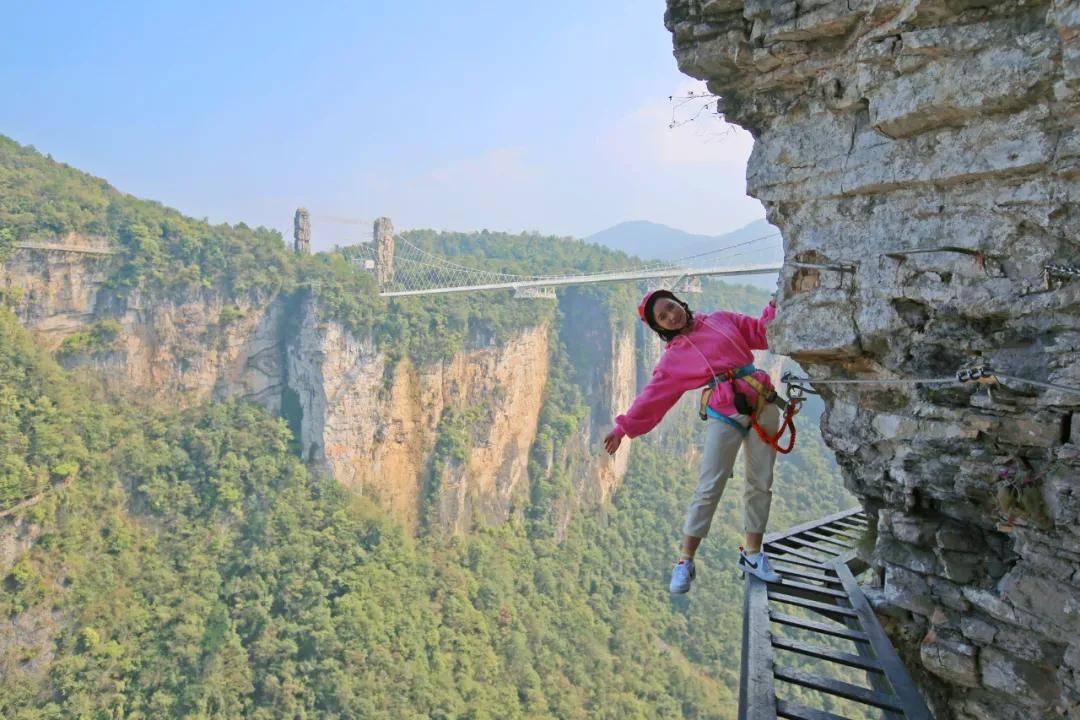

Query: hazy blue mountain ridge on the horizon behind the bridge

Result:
[584,218,784,290]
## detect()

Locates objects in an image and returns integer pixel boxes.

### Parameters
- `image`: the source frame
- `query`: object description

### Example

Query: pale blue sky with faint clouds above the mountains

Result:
[0,0,764,253]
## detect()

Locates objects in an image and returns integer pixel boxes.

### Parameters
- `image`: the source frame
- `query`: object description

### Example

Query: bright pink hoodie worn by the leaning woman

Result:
[615,304,777,437]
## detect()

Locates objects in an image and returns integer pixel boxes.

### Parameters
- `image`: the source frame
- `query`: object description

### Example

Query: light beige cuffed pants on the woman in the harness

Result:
[683,404,780,538]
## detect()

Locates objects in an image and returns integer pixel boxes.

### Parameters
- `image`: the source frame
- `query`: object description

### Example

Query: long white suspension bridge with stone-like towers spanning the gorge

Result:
[295,208,781,298]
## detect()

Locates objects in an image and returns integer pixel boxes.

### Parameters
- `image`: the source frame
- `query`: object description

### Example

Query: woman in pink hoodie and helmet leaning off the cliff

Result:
[604,290,780,594]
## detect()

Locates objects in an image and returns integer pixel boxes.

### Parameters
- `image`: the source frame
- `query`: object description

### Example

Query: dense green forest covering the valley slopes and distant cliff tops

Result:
[0,138,851,720]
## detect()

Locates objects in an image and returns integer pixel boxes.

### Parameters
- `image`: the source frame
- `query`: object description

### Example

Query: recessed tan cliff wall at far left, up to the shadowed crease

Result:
[0,240,283,411]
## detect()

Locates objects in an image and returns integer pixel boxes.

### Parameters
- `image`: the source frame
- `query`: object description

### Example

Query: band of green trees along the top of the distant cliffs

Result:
[0,136,639,363]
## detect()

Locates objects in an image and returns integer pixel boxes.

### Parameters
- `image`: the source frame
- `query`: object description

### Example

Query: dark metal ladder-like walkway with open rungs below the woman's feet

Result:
[739,507,933,720]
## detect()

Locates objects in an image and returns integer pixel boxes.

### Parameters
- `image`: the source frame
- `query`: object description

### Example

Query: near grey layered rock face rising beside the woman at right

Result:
[665,0,1080,719]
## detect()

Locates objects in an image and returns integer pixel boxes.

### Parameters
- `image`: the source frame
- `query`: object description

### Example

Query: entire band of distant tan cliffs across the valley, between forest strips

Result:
[0,249,636,532]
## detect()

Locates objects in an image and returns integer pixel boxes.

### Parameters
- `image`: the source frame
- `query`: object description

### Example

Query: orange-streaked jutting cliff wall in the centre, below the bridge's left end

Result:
[288,302,550,531]
